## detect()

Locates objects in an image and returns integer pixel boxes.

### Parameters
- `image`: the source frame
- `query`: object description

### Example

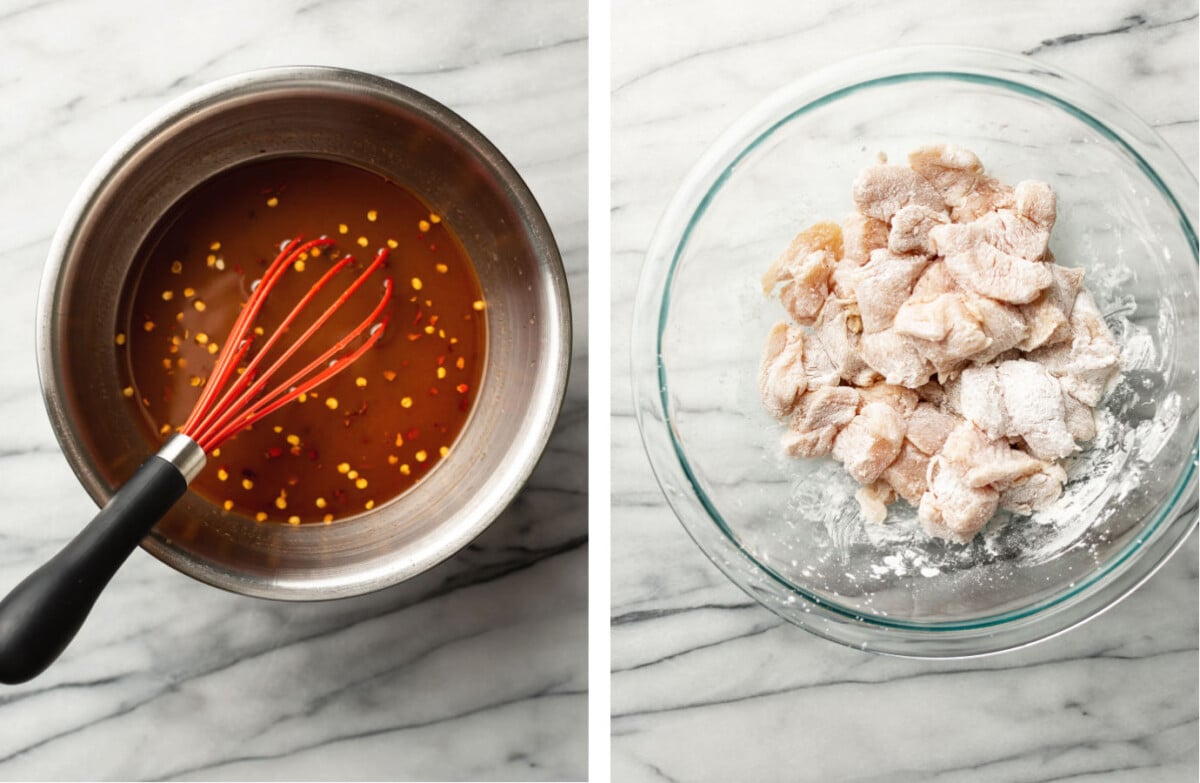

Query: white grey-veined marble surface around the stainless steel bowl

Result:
[0,0,588,779]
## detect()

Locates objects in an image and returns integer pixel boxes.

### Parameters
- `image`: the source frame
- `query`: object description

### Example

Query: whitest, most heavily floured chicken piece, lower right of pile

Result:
[993,359,1075,460]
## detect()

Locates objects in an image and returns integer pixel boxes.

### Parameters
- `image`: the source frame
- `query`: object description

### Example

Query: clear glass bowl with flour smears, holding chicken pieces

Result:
[632,47,1200,657]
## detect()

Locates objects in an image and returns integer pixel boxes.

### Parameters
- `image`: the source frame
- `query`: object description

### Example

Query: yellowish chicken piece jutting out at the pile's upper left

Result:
[762,223,842,324]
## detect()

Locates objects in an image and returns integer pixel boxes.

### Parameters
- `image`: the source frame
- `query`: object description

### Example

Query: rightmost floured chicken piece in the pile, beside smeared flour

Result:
[1030,291,1121,407]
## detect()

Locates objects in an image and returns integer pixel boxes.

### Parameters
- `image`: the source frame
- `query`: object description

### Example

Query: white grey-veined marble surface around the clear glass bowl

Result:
[612,0,1198,783]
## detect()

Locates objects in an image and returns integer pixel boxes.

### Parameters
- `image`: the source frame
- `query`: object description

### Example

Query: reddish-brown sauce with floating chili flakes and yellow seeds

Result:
[115,157,486,525]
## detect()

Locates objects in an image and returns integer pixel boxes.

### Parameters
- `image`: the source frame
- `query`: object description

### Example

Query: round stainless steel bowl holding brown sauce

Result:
[37,67,570,599]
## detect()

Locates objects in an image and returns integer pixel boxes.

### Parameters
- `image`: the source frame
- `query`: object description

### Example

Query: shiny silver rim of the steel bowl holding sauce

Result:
[35,65,572,600]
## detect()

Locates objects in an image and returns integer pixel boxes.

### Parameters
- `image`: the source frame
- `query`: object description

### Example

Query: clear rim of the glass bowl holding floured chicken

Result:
[631,46,1200,658]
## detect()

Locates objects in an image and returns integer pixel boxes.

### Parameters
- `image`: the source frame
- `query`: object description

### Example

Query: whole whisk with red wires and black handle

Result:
[0,238,392,683]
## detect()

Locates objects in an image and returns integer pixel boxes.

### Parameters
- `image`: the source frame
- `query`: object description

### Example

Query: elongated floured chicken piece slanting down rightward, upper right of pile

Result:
[929,223,1054,304]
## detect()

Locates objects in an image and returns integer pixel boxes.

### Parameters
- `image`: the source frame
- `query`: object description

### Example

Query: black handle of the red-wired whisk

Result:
[0,436,204,685]
